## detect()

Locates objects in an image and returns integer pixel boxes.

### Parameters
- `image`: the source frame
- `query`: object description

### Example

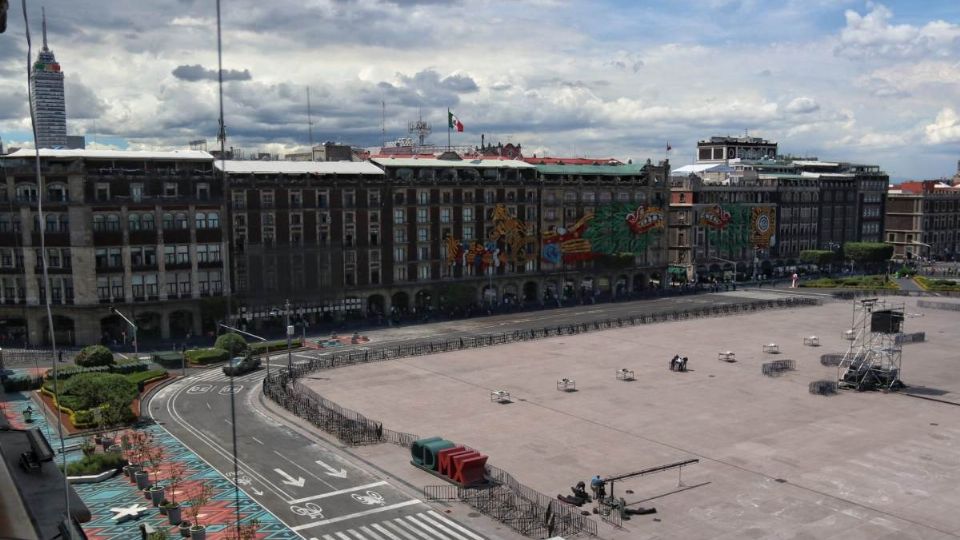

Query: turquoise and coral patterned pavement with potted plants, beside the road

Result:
[3,380,301,540]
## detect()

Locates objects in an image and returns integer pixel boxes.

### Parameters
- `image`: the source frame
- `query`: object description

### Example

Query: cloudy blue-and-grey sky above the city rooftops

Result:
[0,0,960,179]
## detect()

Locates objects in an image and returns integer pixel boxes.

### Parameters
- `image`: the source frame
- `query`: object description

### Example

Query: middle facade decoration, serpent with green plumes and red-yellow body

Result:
[540,204,666,264]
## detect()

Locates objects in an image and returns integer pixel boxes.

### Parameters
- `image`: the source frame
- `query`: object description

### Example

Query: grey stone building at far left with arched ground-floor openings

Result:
[0,149,229,346]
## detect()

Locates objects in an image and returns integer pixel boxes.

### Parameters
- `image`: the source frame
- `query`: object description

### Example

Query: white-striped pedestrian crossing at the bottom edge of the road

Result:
[310,510,484,540]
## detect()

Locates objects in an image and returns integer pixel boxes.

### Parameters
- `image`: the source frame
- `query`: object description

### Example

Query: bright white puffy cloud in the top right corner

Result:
[834,4,960,59]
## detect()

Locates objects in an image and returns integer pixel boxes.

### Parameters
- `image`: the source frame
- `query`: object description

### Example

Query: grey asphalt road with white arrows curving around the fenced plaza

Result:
[148,284,816,540]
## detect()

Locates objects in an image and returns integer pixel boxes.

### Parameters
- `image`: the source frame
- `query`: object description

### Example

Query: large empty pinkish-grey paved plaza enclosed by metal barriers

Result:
[307,299,960,539]
